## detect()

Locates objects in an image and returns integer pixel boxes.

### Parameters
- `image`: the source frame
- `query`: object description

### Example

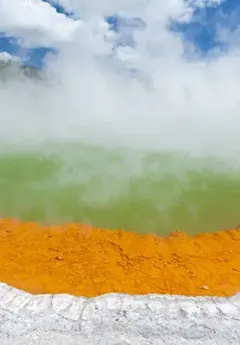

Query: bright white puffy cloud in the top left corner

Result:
[0,0,78,47]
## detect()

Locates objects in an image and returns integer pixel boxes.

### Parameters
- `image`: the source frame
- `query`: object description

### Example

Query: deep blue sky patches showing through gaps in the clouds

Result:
[0,0,240,67]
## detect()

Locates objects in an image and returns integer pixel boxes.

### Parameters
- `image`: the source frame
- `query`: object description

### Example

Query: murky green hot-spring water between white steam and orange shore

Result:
[0,144,240,235]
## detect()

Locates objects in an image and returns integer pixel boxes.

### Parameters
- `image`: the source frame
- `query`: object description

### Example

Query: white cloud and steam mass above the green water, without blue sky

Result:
[0,0,240,161]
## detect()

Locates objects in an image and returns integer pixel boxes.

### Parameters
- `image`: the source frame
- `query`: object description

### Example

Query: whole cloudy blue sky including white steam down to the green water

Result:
[0,0,240,166]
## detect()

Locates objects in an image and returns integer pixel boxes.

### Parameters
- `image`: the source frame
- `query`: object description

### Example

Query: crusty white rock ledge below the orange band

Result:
[0,284,240,345]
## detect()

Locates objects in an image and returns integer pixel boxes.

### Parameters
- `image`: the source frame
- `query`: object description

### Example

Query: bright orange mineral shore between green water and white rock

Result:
[0,219,240,297]
